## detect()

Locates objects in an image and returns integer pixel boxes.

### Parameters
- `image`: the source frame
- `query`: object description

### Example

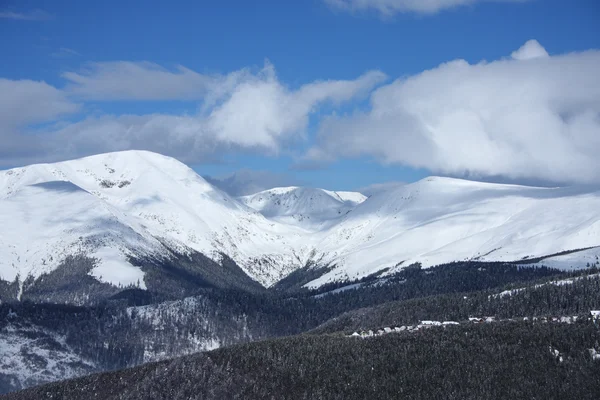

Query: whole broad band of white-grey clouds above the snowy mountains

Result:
[0,40,600,186]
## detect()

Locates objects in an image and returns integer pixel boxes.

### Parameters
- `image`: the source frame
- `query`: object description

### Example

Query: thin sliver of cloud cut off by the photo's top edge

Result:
[324,0,529,16]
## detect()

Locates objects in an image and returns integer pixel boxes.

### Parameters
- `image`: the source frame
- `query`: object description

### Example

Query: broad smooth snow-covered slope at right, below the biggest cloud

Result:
[310,177,600,286]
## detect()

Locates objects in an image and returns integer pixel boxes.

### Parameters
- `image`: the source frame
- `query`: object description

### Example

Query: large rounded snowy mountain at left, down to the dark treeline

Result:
[0,151,308,294]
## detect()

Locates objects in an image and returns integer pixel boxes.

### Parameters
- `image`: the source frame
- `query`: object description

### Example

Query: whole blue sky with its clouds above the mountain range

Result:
[0,0,600,194]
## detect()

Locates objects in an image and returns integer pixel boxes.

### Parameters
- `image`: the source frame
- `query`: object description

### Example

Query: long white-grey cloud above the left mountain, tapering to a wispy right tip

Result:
[0,62,385,165]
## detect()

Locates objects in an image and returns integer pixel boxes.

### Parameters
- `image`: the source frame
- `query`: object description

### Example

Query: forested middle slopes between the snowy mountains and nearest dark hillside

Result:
[0,263,600,393]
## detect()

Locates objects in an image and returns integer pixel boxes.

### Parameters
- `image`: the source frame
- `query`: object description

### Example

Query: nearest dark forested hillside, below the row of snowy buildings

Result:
[6,322,600,400]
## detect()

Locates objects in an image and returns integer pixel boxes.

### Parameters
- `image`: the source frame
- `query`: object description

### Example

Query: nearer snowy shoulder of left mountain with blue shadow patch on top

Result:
[0,177,161,288]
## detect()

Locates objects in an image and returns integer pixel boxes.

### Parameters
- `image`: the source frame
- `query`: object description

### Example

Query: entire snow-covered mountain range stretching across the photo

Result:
[0,151,600,296]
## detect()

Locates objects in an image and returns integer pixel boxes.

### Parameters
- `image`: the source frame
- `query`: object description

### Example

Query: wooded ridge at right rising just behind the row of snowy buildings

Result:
[313,272,600,333]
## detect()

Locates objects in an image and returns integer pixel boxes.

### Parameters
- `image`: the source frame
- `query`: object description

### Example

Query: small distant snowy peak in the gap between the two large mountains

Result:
[239,186,367,231]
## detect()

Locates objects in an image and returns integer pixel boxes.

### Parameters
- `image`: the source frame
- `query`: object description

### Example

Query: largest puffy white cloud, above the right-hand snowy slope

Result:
[307,41,600,182]
